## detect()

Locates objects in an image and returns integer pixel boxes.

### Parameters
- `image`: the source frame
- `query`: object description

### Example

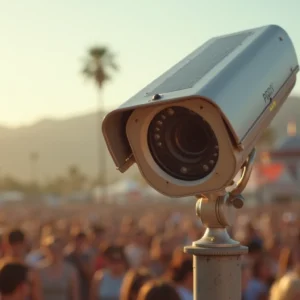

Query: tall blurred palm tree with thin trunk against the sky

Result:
[82,46,118,199]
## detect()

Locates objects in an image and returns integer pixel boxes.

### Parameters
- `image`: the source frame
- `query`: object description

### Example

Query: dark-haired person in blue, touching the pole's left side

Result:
[170,258,193,300]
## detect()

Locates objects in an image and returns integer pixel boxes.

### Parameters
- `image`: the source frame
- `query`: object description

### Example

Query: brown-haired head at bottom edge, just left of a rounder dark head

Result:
[120,268,152,300]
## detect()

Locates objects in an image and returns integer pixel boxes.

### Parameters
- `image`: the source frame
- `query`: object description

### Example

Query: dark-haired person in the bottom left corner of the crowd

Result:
[0,262,30,300]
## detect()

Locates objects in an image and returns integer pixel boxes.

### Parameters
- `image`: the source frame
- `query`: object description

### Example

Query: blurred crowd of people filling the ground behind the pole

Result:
[0,202,300,300]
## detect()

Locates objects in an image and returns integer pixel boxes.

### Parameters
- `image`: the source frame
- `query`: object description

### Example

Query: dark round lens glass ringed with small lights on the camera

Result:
[148,106,219,181]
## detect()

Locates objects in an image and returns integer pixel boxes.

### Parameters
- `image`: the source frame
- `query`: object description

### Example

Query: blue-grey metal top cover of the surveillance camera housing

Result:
[115,25,298,144]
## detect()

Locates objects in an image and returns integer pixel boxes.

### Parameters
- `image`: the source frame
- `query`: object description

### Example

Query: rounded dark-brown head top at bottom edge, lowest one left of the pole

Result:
[137,280,181,300]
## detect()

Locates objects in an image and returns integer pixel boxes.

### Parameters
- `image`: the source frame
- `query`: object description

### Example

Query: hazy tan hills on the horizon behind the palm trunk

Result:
[0,96,300,180]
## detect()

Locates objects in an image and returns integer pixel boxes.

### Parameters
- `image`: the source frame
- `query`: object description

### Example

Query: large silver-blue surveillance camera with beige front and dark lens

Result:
[102,25,299,197]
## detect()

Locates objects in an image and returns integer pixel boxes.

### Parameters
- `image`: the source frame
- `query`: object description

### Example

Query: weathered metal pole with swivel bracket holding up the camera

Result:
[184,150,255,300]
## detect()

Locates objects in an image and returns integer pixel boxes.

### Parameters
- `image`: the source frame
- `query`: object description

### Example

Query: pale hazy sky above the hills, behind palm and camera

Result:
[0,0,300,125]
